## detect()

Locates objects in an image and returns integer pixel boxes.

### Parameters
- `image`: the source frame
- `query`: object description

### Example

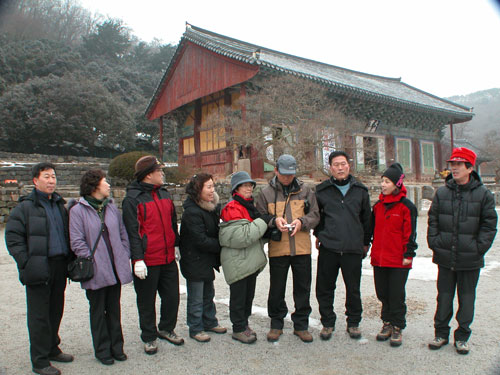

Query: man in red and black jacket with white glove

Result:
[123,155,184,354]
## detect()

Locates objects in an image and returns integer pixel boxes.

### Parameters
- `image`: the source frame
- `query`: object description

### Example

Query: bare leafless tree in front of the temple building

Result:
[205,75,364,177]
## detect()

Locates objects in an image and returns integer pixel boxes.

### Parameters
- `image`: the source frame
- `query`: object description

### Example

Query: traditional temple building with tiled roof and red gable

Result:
[146,24,474,181]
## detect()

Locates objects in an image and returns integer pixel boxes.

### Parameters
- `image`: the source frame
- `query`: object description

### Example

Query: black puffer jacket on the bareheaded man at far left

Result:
[5,189,70,285]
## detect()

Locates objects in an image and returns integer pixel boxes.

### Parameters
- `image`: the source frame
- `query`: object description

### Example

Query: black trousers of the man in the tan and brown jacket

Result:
[267,254,312,331]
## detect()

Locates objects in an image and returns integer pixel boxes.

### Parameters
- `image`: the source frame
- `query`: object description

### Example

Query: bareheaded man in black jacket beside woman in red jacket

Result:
[314,151,371,340]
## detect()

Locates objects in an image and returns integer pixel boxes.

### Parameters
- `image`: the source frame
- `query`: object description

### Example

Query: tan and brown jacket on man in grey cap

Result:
[255,176,319,257]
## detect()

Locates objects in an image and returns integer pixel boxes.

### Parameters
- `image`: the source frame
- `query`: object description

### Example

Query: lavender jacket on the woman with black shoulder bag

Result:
[69,198,132,290]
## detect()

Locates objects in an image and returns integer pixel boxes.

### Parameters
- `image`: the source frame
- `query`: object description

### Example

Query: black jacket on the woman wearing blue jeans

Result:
[180,195,220,281]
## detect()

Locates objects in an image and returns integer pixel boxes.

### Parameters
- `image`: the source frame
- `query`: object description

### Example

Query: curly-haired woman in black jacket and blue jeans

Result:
[180,173,227,342]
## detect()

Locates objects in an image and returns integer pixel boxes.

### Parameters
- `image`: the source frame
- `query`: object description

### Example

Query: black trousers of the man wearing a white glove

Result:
[134,261,179,342]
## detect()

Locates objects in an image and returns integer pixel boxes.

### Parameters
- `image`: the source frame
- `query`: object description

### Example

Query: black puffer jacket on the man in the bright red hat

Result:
[427,171,497,271]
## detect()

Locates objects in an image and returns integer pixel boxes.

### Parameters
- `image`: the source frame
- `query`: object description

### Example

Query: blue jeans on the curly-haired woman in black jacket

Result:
[186,280,219,335]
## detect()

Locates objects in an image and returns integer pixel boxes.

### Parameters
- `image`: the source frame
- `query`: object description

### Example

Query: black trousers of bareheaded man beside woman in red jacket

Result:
[316,250,363,327]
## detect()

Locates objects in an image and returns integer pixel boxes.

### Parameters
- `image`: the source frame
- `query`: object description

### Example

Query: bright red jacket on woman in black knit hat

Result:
[371,185,418,268]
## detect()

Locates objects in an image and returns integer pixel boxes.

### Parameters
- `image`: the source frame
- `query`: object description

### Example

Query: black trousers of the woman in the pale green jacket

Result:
[229,272,259,333]
